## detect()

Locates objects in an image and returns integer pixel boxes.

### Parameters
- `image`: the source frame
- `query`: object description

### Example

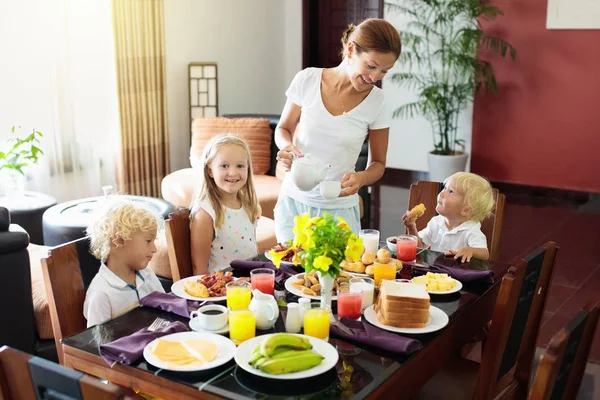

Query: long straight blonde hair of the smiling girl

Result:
[190,133,259,227]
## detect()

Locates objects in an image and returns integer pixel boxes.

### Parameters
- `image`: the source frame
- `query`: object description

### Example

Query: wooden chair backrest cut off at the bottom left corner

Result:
[0,346,127,400]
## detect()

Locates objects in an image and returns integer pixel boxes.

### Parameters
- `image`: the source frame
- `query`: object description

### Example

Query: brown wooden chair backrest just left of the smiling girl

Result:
[165,208,193,282]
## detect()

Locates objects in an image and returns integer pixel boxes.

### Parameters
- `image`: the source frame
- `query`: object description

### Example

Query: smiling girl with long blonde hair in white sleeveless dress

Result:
[190,134,260,275]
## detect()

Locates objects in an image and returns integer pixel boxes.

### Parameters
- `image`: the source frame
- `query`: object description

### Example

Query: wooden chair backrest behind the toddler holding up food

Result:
[408,181,506,260]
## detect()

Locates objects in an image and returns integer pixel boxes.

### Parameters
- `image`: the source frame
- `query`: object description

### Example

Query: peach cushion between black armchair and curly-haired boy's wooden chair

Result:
[27,244,54,339]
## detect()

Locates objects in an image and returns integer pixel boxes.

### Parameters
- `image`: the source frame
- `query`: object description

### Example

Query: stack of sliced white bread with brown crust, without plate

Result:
[374,281,431,328]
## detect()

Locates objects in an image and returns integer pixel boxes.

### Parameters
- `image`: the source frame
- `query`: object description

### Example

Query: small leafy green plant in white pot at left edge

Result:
[0,126,44,197]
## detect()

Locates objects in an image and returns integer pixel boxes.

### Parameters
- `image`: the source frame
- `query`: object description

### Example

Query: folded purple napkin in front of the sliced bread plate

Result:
[330,317,422,355]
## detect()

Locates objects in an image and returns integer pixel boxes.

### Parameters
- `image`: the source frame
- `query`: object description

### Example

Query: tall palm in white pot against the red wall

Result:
[386,0,516,182]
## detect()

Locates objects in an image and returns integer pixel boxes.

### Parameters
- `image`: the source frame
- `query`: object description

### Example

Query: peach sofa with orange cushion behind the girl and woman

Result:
[162,114,370,228]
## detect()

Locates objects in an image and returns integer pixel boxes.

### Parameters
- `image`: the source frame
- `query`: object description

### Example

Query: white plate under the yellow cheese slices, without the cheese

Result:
[144,332,236,372]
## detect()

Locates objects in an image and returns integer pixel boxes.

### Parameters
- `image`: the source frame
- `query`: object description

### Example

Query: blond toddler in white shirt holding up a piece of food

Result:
[402,172,494,262]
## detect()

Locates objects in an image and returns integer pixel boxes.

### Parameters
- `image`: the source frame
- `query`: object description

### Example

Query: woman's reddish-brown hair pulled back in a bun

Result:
[342,18,402,59]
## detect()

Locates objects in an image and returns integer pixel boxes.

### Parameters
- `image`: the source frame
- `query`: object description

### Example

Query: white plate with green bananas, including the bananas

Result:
[234,333,339,380]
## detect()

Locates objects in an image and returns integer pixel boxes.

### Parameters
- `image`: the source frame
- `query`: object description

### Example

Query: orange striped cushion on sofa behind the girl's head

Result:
[190,117,273,175]
